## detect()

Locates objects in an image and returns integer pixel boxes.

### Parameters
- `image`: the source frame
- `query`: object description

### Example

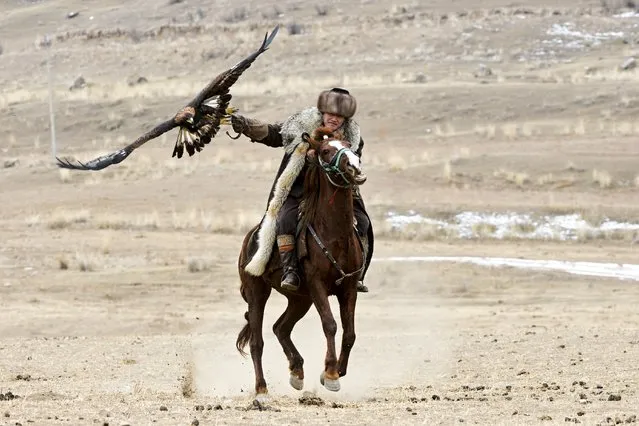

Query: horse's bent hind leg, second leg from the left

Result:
[273,296,313,390]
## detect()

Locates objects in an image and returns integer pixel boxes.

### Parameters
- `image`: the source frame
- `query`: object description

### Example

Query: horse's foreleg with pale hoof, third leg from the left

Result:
[309,282,340,392]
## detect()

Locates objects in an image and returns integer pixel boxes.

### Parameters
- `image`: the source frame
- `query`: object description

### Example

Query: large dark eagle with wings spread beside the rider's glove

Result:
[56,25,279,170]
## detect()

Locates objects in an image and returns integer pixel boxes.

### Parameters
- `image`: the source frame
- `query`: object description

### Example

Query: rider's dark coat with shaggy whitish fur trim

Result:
[245,107,364,276]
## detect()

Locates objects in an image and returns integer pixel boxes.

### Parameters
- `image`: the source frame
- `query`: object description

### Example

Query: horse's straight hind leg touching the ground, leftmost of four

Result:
[248,281,271,400]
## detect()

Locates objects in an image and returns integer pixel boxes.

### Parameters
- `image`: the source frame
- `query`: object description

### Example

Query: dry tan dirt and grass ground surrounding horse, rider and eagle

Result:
[0,0,639,425]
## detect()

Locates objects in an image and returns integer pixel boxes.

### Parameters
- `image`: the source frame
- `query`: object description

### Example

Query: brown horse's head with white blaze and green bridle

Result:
[302,127,366,187]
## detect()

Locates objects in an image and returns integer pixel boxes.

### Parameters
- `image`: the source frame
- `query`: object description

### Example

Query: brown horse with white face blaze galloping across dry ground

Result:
[236,128,366,401]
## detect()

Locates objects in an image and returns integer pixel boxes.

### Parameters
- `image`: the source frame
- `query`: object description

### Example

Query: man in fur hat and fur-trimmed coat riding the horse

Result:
[231,88,373,293]
